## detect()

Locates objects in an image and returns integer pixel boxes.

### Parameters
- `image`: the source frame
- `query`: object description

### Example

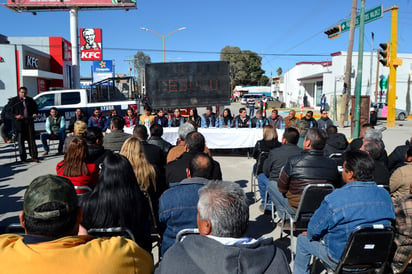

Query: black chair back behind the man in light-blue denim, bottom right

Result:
[336,225,394,273]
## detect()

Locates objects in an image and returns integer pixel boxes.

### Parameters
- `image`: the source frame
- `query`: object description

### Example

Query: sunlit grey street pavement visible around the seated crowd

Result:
[0,112,412,266]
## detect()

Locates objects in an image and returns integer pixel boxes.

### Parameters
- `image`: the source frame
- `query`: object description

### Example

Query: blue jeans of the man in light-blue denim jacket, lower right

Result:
[293,234,337,274]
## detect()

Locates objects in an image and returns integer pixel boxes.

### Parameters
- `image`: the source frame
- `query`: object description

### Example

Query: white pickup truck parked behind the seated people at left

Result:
[33,89,138,131]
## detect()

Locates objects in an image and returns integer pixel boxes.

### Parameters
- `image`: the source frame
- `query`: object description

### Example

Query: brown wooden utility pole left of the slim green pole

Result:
[339,0,358,128]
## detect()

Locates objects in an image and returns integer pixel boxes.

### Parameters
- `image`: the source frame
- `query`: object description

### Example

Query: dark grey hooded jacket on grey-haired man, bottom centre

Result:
[155,235,290,274]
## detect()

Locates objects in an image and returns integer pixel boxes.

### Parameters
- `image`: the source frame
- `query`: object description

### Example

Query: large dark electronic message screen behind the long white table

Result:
[145,61,230,108]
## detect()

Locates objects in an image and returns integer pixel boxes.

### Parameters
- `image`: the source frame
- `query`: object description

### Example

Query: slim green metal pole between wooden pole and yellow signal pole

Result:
[352,0,365,138]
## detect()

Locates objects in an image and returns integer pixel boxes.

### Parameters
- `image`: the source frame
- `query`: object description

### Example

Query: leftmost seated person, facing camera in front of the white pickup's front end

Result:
[40,107,66,155]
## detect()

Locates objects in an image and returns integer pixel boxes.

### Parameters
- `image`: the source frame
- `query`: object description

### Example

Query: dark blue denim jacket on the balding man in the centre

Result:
[159,178,208,255]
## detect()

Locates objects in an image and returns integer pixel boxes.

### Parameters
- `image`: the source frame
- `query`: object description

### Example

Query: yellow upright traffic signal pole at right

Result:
[386,6,402,128]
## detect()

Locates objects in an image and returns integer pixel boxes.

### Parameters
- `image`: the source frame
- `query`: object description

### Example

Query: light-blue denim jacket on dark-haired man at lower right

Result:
[307,182,395,262]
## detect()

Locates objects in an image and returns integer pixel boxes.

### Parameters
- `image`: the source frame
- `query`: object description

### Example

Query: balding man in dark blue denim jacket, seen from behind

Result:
[159,153,213,254]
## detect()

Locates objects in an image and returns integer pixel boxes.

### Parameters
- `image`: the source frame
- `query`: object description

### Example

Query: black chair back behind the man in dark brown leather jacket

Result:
[295,184,335,225]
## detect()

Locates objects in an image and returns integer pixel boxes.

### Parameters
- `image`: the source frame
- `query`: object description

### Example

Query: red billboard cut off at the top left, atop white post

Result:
[4,0,136,11]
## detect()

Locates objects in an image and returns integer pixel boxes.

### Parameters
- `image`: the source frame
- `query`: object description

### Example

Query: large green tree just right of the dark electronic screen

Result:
[220,46,268,90]
